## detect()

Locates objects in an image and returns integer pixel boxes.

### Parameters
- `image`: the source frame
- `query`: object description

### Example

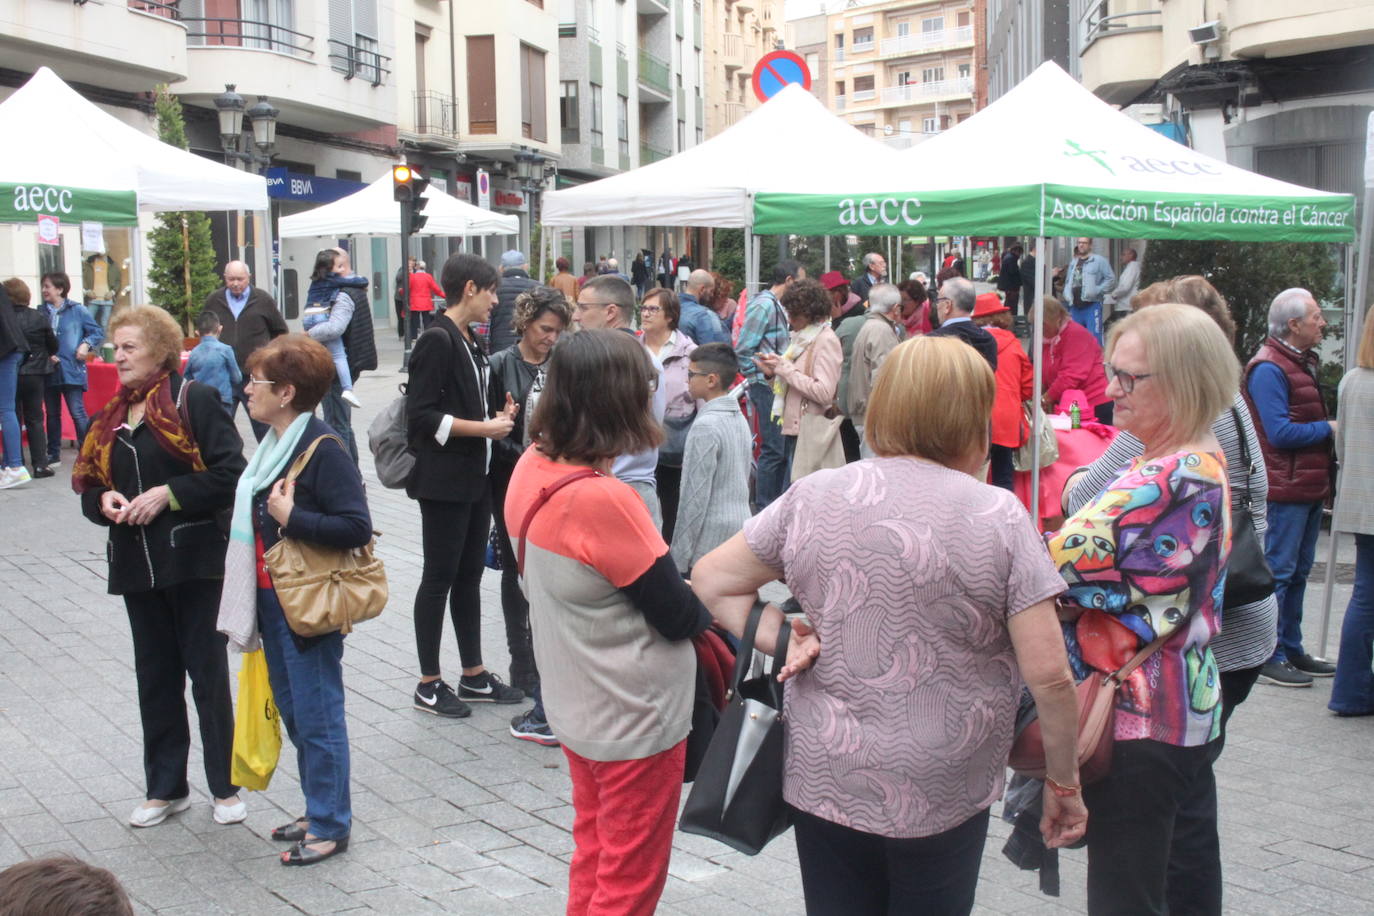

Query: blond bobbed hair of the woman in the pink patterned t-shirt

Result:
[863,335,998,467]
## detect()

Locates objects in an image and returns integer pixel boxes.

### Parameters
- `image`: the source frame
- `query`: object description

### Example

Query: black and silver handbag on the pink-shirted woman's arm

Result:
[677,602,791,856]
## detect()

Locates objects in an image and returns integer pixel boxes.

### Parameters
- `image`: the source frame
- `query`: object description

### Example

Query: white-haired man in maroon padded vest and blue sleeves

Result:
[1245,288,1336,687]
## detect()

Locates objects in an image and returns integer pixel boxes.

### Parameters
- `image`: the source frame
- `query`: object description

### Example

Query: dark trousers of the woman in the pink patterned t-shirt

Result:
[793,809,988,916]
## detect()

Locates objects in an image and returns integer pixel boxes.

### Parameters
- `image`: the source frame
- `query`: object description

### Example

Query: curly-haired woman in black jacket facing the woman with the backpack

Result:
[486,286,573,746]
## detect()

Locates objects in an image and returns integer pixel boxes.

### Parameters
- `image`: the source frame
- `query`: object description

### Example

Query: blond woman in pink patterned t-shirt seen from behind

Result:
[692,336,1087,915]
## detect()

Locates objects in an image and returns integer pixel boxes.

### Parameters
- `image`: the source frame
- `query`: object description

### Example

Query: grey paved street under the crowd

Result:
[0,332,1374,916]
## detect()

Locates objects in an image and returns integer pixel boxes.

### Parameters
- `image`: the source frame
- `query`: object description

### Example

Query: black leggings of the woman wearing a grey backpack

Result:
[415,494,492,677]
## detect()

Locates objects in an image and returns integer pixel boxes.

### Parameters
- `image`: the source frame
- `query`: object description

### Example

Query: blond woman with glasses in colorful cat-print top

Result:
[1050,304,1241,915]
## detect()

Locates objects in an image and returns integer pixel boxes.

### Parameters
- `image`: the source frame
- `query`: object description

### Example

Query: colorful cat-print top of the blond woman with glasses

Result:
[1050,452,1231,747]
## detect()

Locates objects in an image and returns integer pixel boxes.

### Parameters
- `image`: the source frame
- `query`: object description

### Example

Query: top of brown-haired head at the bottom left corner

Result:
[0,856,133,916]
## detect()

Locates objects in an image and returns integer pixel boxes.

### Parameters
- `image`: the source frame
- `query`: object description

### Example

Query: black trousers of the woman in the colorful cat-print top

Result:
[1083,739,1212,916]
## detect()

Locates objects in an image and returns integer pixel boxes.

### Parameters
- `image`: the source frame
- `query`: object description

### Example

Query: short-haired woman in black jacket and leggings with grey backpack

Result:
[405,254,525,718]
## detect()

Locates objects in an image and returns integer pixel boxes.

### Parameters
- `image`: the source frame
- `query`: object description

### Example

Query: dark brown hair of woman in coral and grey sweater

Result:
[529,330,664,464]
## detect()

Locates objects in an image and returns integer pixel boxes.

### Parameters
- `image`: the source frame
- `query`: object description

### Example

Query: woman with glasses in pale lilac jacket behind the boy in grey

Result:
[639,287,697,544]
